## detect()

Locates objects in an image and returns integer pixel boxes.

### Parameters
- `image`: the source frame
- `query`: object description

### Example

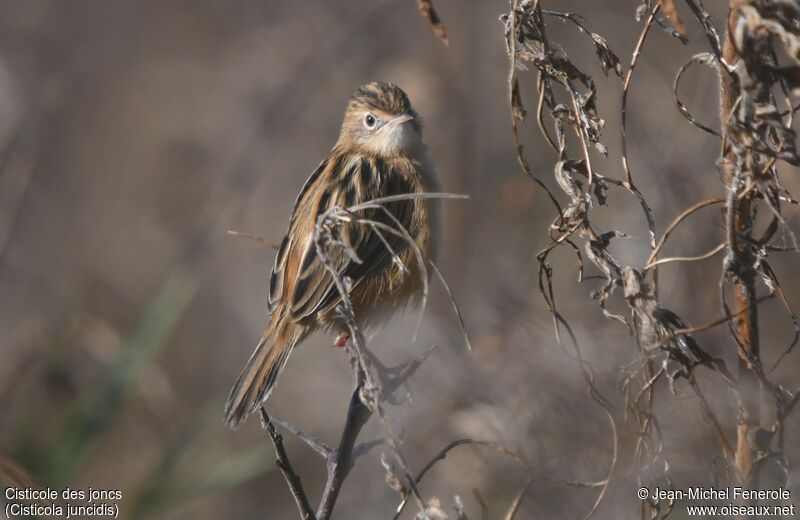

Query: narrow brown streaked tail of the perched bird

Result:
[225,310,307,429]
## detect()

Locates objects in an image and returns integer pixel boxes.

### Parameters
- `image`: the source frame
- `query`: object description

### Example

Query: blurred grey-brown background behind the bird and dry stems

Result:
[0,0,800,519]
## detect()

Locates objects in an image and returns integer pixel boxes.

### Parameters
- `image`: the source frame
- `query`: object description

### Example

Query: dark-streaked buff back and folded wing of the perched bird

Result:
[270,155,412,320]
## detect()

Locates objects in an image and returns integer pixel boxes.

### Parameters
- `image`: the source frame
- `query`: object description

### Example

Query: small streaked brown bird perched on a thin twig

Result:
[225,82,440,428]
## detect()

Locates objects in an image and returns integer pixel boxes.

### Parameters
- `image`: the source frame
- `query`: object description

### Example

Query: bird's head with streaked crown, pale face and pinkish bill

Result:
[339,82,422,157]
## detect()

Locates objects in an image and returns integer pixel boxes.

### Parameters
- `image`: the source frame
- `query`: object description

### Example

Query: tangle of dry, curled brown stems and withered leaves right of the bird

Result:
[501,0,800,518]
